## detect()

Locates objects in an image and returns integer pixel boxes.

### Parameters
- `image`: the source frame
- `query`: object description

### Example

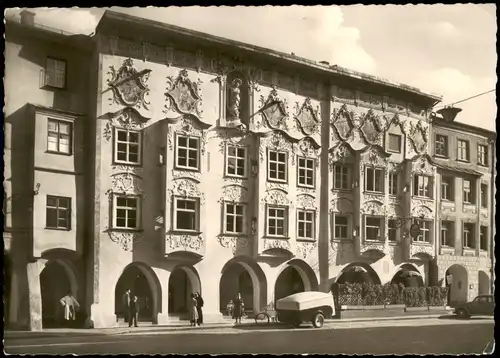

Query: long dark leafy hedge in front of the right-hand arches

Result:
[334,283,448,307]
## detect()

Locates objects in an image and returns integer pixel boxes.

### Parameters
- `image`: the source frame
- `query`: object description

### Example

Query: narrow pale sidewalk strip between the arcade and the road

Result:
[4,312,458,339]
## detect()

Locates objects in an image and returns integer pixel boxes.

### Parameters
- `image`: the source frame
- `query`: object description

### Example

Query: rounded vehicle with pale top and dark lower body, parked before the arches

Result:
[276,291,335,328]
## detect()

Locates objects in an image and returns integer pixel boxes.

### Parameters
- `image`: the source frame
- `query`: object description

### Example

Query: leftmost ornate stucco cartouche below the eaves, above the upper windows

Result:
[108,58,151,109]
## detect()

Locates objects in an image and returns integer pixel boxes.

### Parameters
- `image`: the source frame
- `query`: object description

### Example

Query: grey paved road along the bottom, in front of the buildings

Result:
[5,319,494,354]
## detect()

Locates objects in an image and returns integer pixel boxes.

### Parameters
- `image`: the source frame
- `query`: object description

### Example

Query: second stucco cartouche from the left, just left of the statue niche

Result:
[164,69,203,120]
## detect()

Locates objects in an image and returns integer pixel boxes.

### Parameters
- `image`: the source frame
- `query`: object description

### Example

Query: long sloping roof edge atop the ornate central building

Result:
[95,10,443,106]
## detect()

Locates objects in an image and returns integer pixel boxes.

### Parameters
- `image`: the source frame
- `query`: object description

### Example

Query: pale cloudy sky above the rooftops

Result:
[6,4,497,130]
